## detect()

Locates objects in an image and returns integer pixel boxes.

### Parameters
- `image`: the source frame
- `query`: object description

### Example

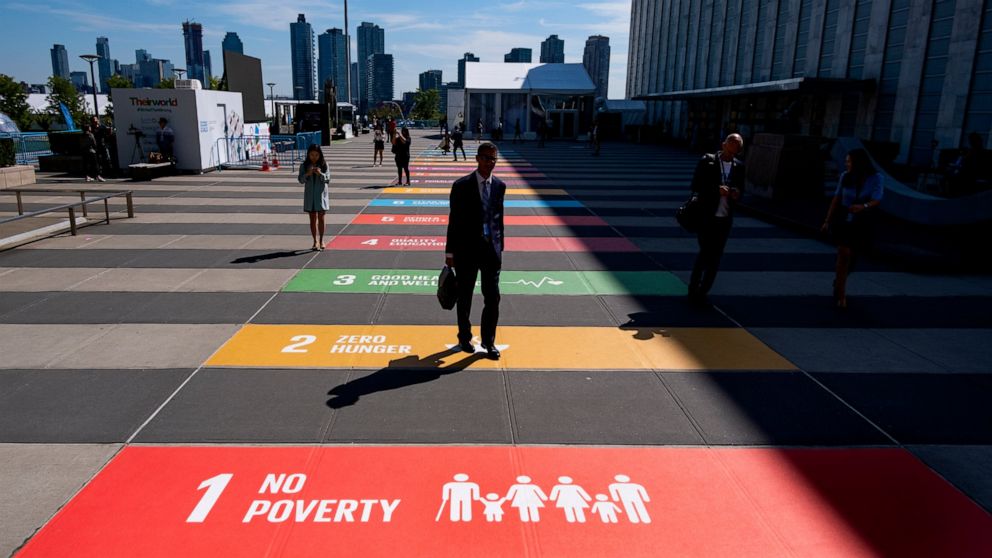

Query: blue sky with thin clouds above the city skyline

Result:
[0,0,630,98]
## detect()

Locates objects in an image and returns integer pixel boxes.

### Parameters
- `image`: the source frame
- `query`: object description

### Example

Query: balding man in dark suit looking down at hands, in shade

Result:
[689,134,744,304]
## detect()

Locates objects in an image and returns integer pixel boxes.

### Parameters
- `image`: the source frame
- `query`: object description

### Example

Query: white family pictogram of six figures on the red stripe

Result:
[434,473,651,524]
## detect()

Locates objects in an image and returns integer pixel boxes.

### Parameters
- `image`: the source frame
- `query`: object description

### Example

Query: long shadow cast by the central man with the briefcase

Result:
[327,347,485,409]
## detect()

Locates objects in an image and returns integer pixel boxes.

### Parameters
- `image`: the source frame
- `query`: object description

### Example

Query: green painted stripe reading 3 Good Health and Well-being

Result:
[284,269,686,296]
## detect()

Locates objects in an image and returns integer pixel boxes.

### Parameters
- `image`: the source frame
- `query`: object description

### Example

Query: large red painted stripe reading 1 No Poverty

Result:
[18,446,992,558]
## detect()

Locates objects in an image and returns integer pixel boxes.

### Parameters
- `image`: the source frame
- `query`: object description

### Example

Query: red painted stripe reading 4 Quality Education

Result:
[327,235,639,252]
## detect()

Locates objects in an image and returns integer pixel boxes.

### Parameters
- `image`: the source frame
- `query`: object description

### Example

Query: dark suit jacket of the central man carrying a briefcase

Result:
[445,171,506,265]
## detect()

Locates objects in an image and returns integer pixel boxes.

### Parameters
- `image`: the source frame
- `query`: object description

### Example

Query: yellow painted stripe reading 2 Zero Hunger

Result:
[207,324,795,371]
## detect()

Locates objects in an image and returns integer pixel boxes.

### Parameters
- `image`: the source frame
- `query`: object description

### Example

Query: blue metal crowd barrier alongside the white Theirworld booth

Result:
[211,132,321,170]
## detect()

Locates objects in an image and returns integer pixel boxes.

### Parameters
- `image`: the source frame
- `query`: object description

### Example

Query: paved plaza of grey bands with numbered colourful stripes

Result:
[0,133,992,558]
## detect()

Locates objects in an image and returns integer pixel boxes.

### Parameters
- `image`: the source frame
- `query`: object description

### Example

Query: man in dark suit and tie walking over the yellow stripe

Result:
[444,142,506,360]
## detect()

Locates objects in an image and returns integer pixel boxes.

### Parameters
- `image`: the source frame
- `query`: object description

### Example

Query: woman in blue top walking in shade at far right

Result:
[820,149,884,308]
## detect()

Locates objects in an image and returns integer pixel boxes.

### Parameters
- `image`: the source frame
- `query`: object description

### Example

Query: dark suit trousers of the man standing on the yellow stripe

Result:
[455,238,502,346]
